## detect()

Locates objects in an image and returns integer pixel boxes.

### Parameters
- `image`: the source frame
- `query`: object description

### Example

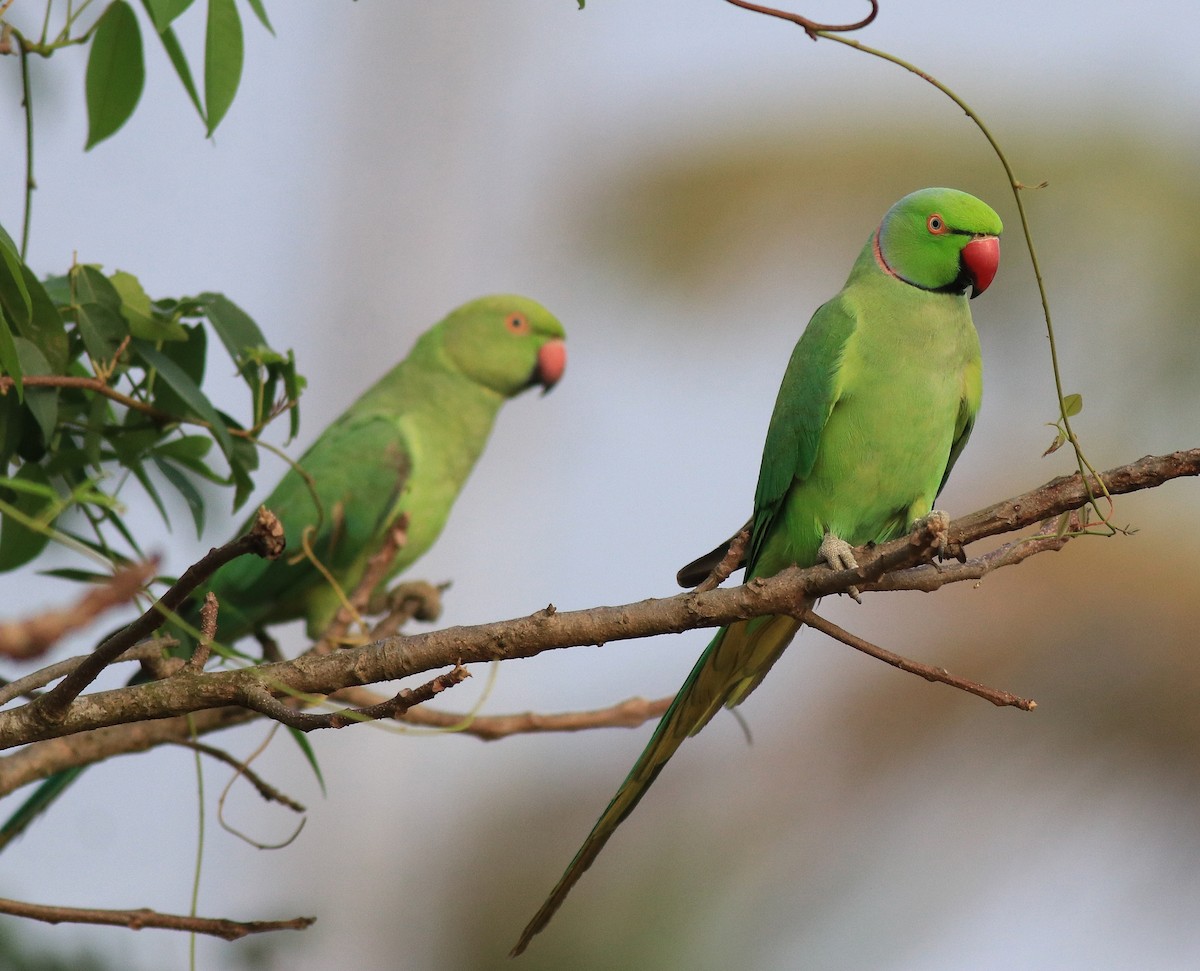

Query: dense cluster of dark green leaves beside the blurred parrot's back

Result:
[0,228,305,571]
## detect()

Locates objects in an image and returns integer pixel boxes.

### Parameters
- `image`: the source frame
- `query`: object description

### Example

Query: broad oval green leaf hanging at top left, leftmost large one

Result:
[84,0,145,151]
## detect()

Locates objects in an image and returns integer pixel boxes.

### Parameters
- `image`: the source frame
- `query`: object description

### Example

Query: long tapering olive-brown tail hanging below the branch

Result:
[510,617,800,958]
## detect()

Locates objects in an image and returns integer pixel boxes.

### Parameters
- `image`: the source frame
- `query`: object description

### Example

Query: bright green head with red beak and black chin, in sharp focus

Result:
[875,188,1004,299]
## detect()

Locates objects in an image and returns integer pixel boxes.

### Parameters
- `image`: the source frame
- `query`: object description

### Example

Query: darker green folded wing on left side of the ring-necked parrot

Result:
[746,294,858,570]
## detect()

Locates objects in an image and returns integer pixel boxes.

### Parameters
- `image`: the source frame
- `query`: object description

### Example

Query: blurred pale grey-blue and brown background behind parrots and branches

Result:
[0,0,1200,971]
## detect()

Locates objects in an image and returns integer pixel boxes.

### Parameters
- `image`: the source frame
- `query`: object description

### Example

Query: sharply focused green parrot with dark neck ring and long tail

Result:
[512,188,1002,957]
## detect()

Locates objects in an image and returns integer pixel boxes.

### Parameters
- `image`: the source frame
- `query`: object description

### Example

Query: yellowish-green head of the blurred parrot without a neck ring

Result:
[443,294,566,397]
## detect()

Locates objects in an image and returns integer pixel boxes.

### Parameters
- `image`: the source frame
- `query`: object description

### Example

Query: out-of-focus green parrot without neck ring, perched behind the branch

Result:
[0,295,566,849]
